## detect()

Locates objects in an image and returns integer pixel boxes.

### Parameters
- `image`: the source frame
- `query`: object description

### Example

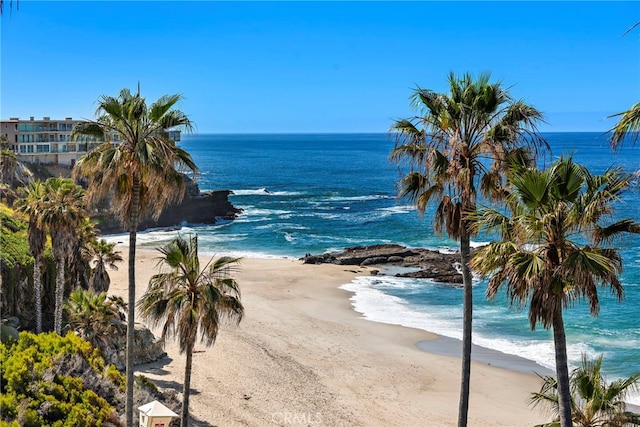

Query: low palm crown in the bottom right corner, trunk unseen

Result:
[531,355,640,427]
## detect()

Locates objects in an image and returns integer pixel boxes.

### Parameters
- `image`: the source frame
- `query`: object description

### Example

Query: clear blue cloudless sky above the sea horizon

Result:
[0,0,640,133]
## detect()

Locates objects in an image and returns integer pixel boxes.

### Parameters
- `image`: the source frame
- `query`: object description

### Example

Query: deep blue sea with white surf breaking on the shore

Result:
[111,133,640,403]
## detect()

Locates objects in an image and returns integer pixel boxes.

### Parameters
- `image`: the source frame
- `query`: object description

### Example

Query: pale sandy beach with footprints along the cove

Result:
[109,247,548,427]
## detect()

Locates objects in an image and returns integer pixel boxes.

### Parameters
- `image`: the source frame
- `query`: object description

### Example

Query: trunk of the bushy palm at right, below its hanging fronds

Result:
[553,302,573,427]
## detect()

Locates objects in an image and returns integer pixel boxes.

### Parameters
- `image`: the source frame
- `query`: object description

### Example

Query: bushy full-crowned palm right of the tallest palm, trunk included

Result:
[471,158,640,427]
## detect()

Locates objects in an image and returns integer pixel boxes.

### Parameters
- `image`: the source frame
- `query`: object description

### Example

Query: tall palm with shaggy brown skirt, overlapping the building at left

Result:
[71,89,197,425]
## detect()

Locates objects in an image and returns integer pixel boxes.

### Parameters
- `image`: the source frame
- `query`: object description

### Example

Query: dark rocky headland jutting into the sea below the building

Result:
[92,177,241,234]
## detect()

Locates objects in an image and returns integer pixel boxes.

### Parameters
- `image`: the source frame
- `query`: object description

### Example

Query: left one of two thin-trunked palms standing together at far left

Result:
[16,181,47,333]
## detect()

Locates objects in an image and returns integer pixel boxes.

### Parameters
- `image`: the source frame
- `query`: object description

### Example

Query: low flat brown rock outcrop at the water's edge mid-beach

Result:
[301,244,462,285]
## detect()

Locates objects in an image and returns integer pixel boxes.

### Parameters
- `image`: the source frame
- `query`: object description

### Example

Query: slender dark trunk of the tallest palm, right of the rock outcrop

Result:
[458,231,473,427]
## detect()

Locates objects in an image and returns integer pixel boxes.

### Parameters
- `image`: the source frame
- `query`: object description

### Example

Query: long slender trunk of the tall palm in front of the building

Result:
[125,176,140,427]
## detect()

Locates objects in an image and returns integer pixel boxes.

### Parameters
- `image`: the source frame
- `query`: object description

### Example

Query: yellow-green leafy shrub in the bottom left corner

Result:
[0,332,122,427]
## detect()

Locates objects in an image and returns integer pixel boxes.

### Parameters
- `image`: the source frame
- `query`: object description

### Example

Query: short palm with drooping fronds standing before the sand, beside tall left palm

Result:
[138,235,244,427]
